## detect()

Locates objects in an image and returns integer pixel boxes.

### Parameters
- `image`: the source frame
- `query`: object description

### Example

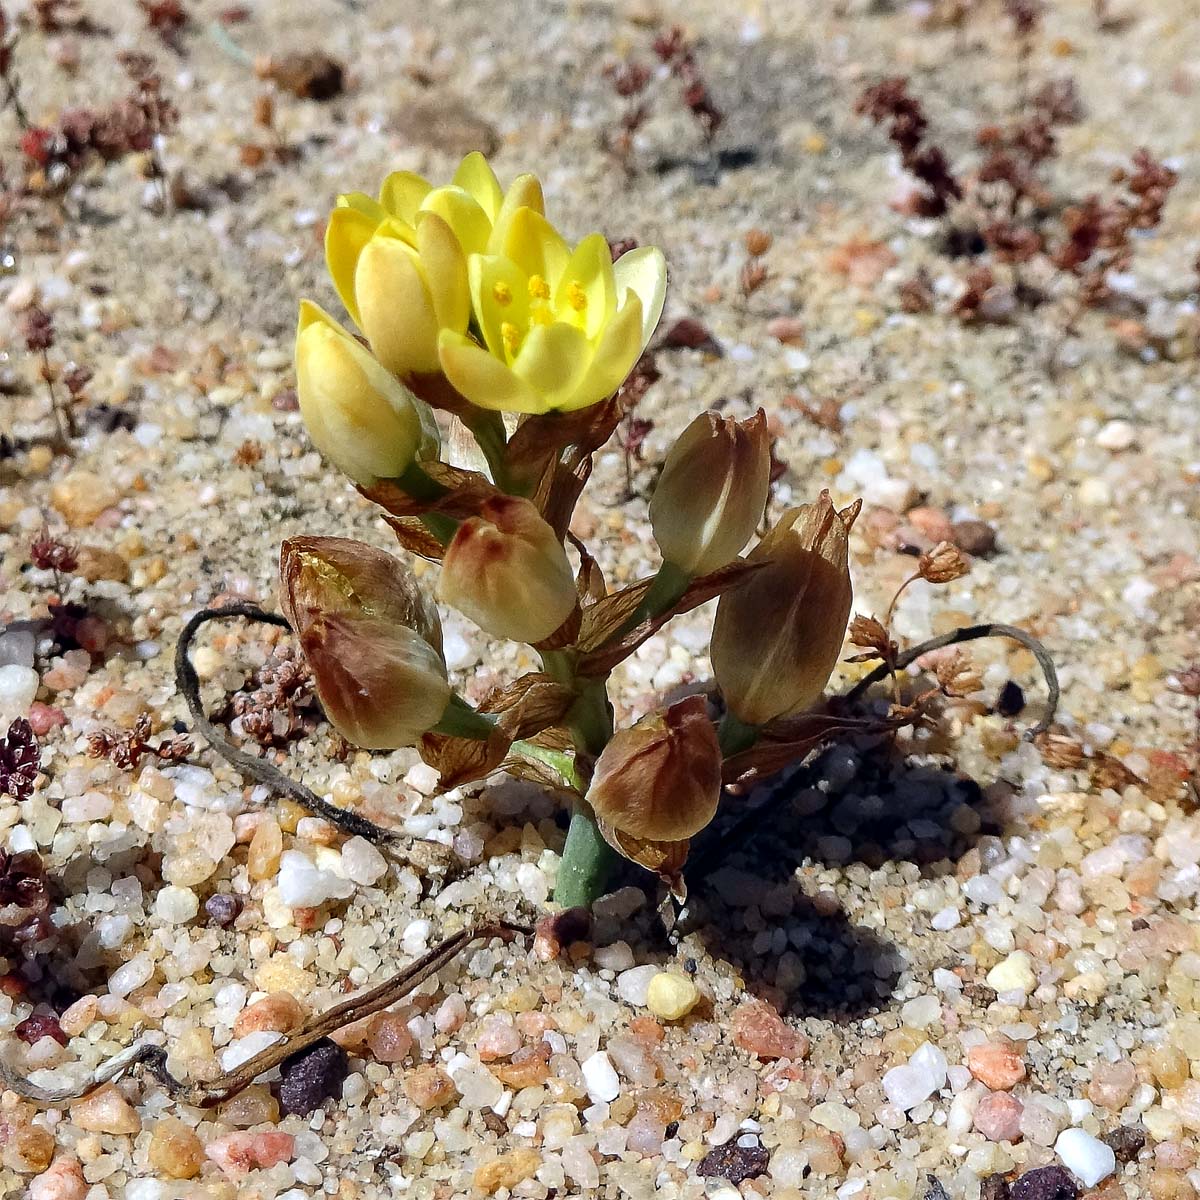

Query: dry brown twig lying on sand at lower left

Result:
[0,920,532,1109]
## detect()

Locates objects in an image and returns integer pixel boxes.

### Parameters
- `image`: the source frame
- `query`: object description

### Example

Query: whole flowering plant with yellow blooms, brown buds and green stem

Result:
[291,154,858,904]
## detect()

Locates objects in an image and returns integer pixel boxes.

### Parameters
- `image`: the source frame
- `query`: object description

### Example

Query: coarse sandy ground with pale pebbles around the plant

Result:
[0,0,1200,1200]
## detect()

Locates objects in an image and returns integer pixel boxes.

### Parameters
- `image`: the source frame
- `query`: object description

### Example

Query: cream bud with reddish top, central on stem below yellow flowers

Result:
[438,496,576,642]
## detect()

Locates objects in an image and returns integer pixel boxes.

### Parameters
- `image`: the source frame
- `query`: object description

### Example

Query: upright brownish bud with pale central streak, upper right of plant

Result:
[650,408,770,575]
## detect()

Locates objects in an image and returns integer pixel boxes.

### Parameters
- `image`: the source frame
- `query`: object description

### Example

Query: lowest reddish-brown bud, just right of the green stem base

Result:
[588,696,721,841]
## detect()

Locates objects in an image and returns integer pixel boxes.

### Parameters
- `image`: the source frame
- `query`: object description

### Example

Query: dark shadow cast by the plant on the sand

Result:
[684,740,1001,1022]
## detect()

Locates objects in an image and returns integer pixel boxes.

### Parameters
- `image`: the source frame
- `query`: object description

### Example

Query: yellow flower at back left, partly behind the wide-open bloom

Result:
[325,154,542,376]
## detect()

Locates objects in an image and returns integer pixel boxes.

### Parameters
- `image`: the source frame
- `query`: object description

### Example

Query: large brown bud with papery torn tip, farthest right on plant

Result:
[710,492,859,725]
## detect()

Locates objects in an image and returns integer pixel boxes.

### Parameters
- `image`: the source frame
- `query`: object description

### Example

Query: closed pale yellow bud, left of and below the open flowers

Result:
[295,300,437,487]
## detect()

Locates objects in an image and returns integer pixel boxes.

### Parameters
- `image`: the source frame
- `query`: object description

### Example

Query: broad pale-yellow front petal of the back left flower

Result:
[354,238,438,376]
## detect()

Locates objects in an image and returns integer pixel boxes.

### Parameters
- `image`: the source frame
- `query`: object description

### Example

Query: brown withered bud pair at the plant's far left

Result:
[280,538,450,750]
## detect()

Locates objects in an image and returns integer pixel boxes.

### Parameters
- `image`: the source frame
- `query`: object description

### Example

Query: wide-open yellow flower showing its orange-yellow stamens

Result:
[438,213,666,413]
